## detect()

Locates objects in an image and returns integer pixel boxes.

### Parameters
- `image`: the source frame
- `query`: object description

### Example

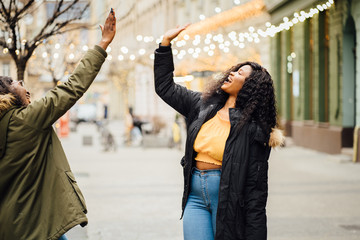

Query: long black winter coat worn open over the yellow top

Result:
[154,46,271,240]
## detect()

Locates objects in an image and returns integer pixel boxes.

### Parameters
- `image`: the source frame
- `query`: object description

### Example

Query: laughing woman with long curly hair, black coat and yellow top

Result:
[154,25,284,240]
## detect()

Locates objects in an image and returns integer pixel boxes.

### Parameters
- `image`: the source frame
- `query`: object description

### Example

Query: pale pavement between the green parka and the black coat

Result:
[62,125,182,240]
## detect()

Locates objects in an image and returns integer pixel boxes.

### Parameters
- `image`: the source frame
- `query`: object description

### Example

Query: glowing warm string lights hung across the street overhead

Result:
[3,0,334,61]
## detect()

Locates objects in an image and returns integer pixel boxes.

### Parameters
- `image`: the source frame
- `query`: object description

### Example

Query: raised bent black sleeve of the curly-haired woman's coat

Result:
[154,46,201,117]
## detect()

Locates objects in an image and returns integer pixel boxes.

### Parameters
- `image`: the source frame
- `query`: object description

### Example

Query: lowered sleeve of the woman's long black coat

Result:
[245,125,270,240]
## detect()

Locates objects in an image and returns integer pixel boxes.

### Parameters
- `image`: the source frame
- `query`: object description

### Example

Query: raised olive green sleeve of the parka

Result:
[17,46,107,129]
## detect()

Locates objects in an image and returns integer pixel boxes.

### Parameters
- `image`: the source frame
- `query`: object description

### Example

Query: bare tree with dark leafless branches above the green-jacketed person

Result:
[0,0,90,79]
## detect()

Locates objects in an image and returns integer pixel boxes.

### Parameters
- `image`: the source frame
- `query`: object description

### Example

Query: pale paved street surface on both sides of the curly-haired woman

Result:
[62,124,360,240]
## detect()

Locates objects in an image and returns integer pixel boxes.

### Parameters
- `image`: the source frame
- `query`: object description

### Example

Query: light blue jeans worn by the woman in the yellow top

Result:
[183,168,221,240]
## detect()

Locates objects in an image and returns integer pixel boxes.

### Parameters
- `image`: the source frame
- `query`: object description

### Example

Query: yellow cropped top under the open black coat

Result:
[194,113,230,166]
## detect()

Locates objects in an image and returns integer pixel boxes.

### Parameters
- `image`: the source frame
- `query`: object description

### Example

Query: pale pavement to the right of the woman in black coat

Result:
[268,146,360,240]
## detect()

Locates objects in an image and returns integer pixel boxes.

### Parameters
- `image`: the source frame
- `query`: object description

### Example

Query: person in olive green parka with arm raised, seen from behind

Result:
[0,9,116,240]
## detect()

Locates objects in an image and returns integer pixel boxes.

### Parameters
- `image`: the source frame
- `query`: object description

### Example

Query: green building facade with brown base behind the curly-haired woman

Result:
[266,0,360,159]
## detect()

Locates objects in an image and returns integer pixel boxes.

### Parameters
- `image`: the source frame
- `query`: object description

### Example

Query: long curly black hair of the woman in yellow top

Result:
[203,61,277,135]
